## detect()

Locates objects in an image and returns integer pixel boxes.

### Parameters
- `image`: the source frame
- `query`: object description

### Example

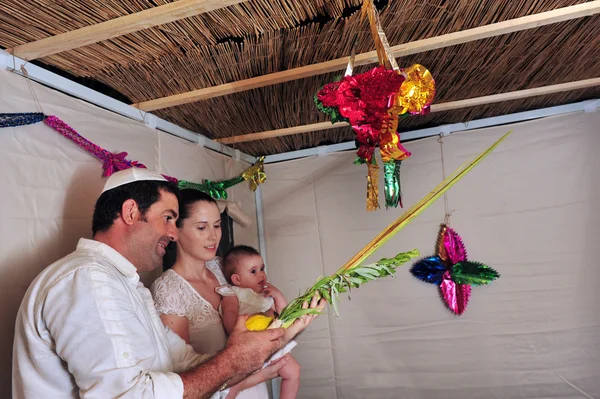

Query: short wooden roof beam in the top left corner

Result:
[7,0,247,61]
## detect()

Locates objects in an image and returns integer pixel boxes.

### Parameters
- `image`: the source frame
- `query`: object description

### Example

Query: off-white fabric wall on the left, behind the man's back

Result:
[0,71,258,397]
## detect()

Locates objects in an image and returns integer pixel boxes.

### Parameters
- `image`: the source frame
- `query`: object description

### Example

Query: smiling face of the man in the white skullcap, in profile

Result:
[129,190,179,271]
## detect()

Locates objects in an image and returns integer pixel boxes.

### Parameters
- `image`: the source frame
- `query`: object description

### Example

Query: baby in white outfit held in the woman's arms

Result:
[217,245,300,399]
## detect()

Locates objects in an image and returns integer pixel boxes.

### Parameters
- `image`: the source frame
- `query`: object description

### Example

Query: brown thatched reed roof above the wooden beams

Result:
[0,0,600,155]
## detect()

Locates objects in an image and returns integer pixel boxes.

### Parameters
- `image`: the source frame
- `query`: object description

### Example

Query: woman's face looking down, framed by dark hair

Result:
[177,201,221,262]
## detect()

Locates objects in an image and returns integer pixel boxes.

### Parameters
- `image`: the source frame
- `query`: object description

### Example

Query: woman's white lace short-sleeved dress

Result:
[150,259,269,399]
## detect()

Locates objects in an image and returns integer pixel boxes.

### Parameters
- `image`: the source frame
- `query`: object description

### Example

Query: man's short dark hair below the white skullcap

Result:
[92,180,179,235]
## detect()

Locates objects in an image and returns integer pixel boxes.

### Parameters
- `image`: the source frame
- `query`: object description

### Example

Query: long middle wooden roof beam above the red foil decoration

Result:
[133,0,600,111]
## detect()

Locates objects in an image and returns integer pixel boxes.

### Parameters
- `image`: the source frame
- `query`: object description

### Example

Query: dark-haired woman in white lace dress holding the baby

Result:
[150,190,277,399]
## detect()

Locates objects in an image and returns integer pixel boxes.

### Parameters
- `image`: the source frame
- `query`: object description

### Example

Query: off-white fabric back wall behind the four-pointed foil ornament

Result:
[263,113,600,399]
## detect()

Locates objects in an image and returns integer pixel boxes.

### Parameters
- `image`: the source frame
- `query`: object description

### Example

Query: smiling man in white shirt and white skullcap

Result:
[13,168,324,398]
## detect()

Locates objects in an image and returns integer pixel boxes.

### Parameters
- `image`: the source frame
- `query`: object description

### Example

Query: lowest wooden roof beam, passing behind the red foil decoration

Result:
[216,78,600,144]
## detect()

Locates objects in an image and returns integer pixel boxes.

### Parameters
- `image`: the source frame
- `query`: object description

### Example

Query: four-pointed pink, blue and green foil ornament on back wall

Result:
[410,224,500,315]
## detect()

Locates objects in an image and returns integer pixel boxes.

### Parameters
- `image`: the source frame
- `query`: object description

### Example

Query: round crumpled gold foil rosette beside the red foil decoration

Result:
[397,64,435,114]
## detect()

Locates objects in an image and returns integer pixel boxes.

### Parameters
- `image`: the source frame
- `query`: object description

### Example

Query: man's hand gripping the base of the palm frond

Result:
[224,315,284,376]
